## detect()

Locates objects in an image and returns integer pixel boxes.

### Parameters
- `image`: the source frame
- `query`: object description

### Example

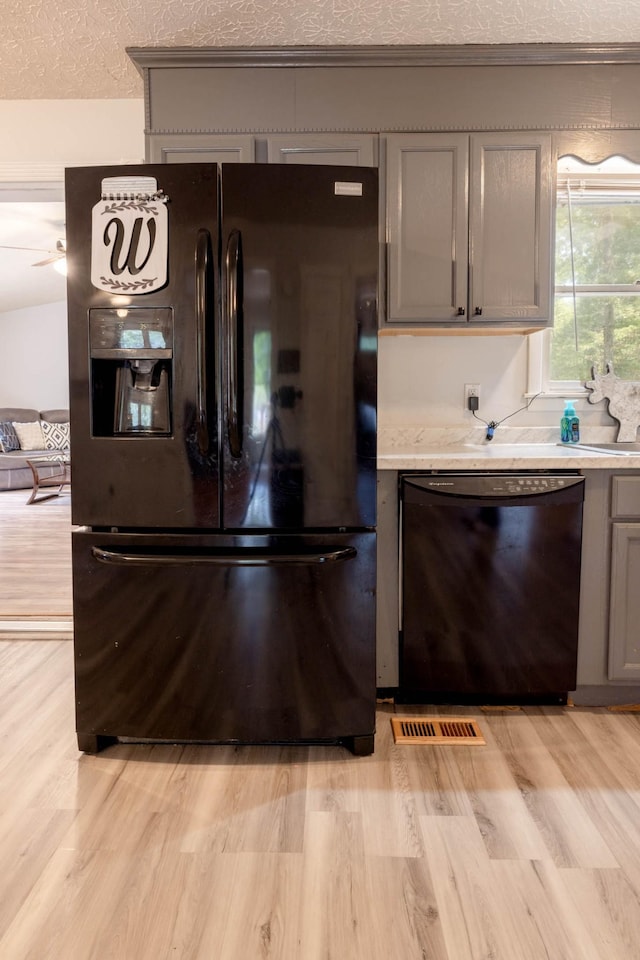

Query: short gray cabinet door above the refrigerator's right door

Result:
[267,133,378,167]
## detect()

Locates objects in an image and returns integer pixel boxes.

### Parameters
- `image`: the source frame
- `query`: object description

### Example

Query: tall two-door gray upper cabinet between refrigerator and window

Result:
[387,132,553,326]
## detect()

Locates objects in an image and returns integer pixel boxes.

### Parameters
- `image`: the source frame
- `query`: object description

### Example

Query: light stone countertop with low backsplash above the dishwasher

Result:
[377,426,640,470]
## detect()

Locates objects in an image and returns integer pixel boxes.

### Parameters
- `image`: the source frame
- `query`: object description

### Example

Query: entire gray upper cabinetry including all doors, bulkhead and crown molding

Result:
[128,44,640,333]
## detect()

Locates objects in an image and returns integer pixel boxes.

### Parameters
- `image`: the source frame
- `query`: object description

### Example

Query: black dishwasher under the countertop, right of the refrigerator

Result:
[397,471,584,704]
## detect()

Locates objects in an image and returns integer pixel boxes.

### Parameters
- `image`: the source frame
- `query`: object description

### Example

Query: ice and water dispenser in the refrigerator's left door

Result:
[89,307,173,437]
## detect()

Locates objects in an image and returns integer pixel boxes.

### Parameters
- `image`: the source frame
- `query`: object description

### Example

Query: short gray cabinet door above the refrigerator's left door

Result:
[147,133,255,163]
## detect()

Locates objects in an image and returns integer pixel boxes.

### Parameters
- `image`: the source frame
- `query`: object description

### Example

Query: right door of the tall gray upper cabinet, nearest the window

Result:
[469,133,553,323]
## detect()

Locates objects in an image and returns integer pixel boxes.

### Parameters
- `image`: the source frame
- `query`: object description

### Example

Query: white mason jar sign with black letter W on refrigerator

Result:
[91,186,169,297]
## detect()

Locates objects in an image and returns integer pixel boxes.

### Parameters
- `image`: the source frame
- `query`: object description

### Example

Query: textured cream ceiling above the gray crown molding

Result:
[0,0,640,100]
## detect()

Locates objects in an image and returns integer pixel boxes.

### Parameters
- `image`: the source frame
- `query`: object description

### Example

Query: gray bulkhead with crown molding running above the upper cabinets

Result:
[128,43,640,137]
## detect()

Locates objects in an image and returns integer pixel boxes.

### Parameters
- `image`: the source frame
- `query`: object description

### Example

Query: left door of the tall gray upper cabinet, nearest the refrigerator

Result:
[387,133,469,323]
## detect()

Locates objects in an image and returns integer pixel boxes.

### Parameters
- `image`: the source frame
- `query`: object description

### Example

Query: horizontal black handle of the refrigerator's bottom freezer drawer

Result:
[91,547,358,567]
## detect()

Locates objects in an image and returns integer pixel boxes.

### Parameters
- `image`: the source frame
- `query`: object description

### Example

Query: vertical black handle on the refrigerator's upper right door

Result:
[225,230,242,460]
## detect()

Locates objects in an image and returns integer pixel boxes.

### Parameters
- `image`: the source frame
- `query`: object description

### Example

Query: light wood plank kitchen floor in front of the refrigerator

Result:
[0,492,640,960]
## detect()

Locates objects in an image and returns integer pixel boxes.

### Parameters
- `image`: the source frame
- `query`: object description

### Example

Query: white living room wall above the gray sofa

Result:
[0,300,69,410]
